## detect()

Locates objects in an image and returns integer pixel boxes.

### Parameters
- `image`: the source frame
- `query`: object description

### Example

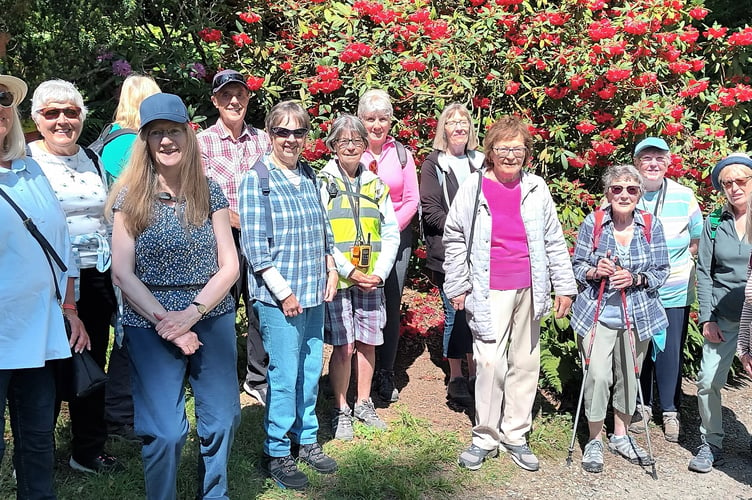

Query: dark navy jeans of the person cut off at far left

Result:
[0,366,56,500]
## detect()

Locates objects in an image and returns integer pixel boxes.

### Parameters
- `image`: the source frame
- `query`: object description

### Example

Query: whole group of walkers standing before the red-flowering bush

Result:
[0,64,752,498]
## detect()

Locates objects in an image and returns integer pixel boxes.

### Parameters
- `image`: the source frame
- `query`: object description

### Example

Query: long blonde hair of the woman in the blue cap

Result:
[105,123,210,238]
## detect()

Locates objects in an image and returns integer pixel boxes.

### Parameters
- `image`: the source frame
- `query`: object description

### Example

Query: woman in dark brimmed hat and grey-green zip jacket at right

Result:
[689,153,752,472]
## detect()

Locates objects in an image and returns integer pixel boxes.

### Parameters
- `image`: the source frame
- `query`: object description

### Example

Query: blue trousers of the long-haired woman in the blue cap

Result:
[125,313,240,500]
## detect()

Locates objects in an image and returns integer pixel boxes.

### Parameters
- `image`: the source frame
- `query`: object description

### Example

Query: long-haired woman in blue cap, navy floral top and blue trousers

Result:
[108,94,240,500]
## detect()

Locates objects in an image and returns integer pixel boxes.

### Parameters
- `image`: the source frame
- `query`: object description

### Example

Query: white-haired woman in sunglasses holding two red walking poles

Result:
[572,165,669,472]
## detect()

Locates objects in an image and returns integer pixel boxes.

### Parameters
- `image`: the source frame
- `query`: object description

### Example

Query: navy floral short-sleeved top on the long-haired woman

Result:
[113,180,234,328]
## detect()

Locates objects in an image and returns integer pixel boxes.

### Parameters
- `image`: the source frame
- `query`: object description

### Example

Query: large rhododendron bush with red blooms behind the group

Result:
[195,0,752,216]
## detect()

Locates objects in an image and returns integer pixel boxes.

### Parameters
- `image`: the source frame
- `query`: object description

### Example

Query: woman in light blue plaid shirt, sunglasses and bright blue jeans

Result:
[239,101,338,489]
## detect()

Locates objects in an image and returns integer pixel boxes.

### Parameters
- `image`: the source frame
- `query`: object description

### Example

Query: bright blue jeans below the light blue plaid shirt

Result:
[253,301,324,457]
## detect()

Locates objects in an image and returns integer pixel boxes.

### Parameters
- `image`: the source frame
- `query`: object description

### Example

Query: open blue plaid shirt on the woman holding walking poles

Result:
[571,207,669,340]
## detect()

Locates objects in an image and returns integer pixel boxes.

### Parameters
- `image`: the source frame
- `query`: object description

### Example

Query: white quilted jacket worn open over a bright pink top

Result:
[443,172,577,341]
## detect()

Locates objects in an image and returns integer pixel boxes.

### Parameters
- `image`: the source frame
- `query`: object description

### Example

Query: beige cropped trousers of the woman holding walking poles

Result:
[580,323,650,422]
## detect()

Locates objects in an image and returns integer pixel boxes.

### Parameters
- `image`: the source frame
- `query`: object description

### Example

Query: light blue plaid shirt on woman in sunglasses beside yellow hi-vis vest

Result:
[238,155,334,308]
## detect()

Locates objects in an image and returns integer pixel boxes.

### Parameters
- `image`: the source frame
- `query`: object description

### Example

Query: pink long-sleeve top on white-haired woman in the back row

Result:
[360,136,420,231]
